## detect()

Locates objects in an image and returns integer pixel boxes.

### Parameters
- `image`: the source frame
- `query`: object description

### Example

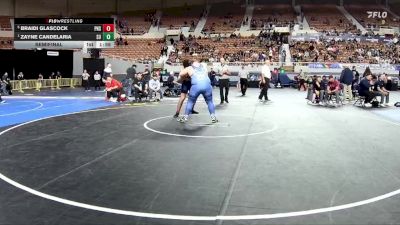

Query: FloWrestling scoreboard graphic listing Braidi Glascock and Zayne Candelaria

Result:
[14,18,115,49]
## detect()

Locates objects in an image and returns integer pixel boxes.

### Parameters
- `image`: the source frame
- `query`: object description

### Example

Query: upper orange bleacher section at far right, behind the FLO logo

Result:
[345,5,400,29]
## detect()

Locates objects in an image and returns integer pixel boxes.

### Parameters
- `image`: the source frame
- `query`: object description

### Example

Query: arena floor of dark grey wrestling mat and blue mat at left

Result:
[0,88,400,225]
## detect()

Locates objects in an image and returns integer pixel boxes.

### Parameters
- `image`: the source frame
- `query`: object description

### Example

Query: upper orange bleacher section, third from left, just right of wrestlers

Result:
[203,3,246,33]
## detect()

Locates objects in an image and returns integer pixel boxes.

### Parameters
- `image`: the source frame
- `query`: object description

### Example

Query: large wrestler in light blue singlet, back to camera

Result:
[180,63,217,123]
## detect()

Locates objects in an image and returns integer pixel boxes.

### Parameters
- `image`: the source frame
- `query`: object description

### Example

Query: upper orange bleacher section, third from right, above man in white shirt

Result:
[252,4,296,29]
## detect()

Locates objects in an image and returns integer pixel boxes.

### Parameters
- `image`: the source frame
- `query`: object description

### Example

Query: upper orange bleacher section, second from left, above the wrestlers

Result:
[160,5,205,30]
